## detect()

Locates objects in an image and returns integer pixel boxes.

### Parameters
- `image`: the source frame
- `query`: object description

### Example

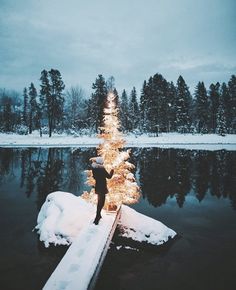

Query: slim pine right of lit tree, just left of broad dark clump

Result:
[129,87,139,132]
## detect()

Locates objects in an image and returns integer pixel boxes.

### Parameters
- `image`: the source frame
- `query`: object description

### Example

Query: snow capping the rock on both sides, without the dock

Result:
[35,191,176,247]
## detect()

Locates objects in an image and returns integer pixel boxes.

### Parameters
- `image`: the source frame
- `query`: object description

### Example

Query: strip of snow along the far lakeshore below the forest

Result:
[0,132,236,150]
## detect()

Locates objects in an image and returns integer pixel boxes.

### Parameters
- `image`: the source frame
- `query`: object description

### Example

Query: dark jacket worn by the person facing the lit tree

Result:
[92,165,114,194]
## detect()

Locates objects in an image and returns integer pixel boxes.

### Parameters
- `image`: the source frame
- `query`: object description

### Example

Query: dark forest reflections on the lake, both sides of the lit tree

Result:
[0,148,236,209]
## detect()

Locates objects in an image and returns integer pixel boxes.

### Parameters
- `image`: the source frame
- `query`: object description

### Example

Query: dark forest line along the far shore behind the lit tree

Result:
[0,69,236,137]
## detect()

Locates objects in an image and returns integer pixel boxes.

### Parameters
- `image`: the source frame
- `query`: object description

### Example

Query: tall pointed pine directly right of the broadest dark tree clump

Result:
[176,76,191,133]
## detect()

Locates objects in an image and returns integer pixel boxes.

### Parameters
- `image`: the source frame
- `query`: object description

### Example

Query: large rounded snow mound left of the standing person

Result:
[35,191,95,247]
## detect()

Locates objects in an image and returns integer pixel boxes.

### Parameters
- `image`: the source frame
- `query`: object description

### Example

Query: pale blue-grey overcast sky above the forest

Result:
[0,0,236,92]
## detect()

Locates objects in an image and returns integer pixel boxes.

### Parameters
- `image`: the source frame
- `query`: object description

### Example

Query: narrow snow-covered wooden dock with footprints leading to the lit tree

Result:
[43,207,121,290]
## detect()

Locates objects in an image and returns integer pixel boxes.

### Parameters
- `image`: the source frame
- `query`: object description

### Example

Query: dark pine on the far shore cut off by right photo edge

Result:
[228,75,236,134]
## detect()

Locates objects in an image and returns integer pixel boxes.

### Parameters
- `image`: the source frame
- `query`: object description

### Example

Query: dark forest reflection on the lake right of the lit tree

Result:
[136,148,236,209]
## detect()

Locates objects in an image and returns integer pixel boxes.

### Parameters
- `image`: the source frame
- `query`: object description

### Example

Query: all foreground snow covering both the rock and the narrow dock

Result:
[36,191,176,290]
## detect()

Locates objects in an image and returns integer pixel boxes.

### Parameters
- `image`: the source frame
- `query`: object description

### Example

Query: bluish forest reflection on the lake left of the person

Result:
[0,148,95,208]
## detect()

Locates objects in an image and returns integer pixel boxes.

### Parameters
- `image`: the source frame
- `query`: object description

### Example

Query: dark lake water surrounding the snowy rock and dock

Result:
[0,148,236,290]
